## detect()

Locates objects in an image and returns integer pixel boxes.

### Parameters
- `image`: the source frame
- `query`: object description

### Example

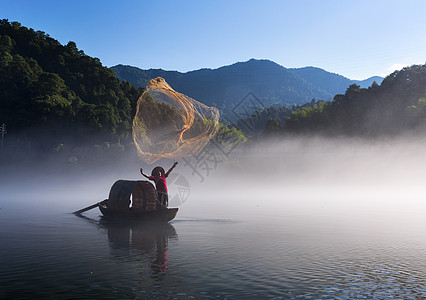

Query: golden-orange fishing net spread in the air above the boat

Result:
[133,77,219,164]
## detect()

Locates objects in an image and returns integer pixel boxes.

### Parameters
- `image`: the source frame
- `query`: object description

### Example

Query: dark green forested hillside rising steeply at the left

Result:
[0,20,142,155]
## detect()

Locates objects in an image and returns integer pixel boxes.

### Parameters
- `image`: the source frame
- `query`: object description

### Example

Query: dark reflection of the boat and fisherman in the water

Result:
[101,218,177,280]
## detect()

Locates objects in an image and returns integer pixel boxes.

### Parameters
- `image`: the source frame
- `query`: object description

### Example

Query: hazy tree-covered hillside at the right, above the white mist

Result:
[269,65,426,137]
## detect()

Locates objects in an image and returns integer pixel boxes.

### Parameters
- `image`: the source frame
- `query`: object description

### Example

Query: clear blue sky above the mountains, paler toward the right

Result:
[0,0,426,79]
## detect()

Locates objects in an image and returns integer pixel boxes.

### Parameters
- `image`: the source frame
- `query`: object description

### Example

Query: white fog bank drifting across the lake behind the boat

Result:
[0,138,426,218]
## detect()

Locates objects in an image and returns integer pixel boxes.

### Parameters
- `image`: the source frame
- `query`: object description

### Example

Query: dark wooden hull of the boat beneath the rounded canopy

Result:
[98,199,179,222]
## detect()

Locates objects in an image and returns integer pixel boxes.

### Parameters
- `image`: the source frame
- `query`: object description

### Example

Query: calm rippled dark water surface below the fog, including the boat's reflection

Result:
[0,197,426,299]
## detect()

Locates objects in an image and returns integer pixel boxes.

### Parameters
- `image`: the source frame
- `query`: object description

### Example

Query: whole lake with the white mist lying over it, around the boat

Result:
[0,139,426,299]
